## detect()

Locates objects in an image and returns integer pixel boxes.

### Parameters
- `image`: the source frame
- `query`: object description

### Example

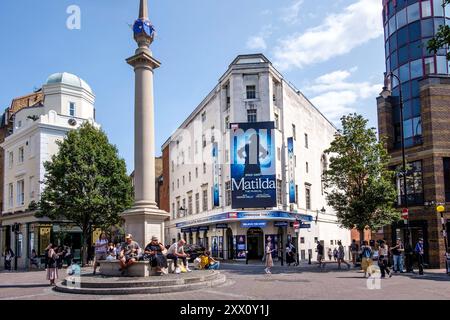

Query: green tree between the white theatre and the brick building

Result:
[324,114,400,241]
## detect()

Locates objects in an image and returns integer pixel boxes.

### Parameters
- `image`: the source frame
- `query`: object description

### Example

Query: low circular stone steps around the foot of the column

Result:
[54,270,226,295]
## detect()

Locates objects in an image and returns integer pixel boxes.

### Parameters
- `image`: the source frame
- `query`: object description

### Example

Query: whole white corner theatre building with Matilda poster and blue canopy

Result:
[161,54,350,259]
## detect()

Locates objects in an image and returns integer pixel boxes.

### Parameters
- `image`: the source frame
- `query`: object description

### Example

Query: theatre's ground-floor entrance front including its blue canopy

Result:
[176,211,312,260]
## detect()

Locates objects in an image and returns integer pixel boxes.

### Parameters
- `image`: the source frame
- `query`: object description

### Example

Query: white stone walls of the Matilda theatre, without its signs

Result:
[163,55,350,259]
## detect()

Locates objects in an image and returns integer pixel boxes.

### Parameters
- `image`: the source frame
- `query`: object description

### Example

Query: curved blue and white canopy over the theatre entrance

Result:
[176,210,313,228]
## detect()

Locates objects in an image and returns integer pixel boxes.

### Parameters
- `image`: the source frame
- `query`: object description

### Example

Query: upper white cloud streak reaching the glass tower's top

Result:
[274,0,383,70]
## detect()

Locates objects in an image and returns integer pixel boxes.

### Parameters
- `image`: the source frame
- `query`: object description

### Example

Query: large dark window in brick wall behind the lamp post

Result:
[396,160,424,206]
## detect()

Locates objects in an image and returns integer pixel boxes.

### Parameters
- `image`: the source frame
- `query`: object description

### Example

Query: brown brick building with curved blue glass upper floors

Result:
[377,0,450,268]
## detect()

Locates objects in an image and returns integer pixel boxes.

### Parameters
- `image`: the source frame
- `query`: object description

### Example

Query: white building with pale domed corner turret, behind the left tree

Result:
[1,73,95,268]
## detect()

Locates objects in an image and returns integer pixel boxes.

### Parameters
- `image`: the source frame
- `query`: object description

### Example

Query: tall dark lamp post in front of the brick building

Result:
[380,71,412,248]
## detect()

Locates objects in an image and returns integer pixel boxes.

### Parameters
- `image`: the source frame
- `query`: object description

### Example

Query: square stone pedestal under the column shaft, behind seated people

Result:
[122,204,170,248]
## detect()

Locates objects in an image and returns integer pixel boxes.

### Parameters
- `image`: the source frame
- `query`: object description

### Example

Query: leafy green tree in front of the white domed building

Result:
[35,122,133,264]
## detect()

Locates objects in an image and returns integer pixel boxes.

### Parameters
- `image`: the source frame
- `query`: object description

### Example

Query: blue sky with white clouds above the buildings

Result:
[0,0,384,171]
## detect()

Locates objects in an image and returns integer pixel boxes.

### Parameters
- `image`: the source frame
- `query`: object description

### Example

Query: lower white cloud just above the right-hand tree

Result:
[305,67,382,122]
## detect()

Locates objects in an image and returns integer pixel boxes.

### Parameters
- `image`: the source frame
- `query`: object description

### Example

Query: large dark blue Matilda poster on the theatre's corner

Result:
[230,122,277,209]
